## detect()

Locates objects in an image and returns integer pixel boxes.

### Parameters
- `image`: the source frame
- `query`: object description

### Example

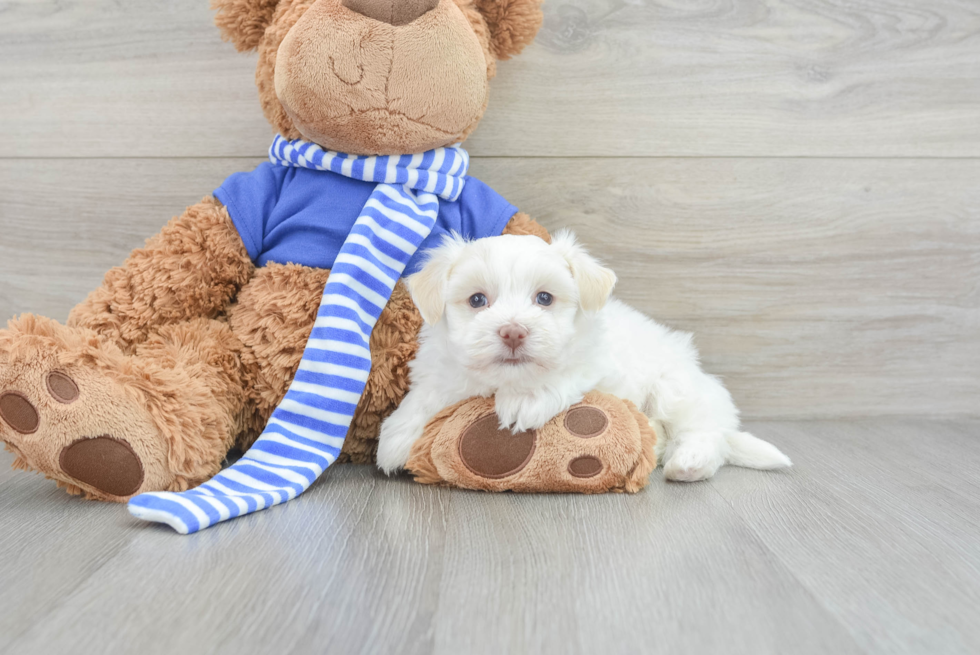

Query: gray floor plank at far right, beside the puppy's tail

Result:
[710,420,980,654]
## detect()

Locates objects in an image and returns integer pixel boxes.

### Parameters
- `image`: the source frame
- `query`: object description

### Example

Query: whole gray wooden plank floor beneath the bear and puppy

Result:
[0,419,980,655]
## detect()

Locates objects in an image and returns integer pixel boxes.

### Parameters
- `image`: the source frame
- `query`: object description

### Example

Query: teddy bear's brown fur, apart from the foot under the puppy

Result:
[0,0,548,501]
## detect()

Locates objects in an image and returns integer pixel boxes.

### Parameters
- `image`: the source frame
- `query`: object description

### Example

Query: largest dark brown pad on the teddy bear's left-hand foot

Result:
[58,435,143,496]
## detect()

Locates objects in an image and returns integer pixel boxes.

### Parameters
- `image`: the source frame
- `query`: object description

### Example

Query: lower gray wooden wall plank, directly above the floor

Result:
[0,158,980,418]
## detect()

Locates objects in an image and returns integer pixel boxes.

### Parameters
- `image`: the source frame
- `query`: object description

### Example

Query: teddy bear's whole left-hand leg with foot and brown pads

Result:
[0,316,250,501]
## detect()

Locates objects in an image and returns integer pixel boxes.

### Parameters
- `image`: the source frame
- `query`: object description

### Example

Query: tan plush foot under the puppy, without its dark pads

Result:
[407,391,657,493]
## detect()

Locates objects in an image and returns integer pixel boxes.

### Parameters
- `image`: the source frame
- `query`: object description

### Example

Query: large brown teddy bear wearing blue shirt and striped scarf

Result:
[0,0,649,532]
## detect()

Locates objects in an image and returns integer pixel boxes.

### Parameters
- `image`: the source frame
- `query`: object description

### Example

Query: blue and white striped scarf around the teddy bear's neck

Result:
[129,136,469,534]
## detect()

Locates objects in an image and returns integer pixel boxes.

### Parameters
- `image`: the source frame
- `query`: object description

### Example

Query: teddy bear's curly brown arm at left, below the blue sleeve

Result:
[68,197,254,351]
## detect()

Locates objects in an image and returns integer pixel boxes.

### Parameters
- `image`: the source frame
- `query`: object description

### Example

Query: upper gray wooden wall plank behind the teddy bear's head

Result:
[0,0,980,157]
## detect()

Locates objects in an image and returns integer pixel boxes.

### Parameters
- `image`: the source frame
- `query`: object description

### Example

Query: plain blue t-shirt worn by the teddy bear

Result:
[214,162,517,275]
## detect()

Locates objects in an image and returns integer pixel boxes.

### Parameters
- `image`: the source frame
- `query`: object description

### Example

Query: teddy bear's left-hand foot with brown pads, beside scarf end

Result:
[0,316,172,501]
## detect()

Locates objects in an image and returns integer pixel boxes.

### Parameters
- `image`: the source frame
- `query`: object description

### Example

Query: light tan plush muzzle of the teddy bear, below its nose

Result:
[274,0,489,155]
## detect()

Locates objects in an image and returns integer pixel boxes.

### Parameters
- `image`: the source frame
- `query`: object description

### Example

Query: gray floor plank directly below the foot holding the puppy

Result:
[435,480,860,655]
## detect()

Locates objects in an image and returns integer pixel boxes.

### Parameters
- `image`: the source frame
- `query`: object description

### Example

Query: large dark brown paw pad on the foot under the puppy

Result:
[459,414,537,480]
